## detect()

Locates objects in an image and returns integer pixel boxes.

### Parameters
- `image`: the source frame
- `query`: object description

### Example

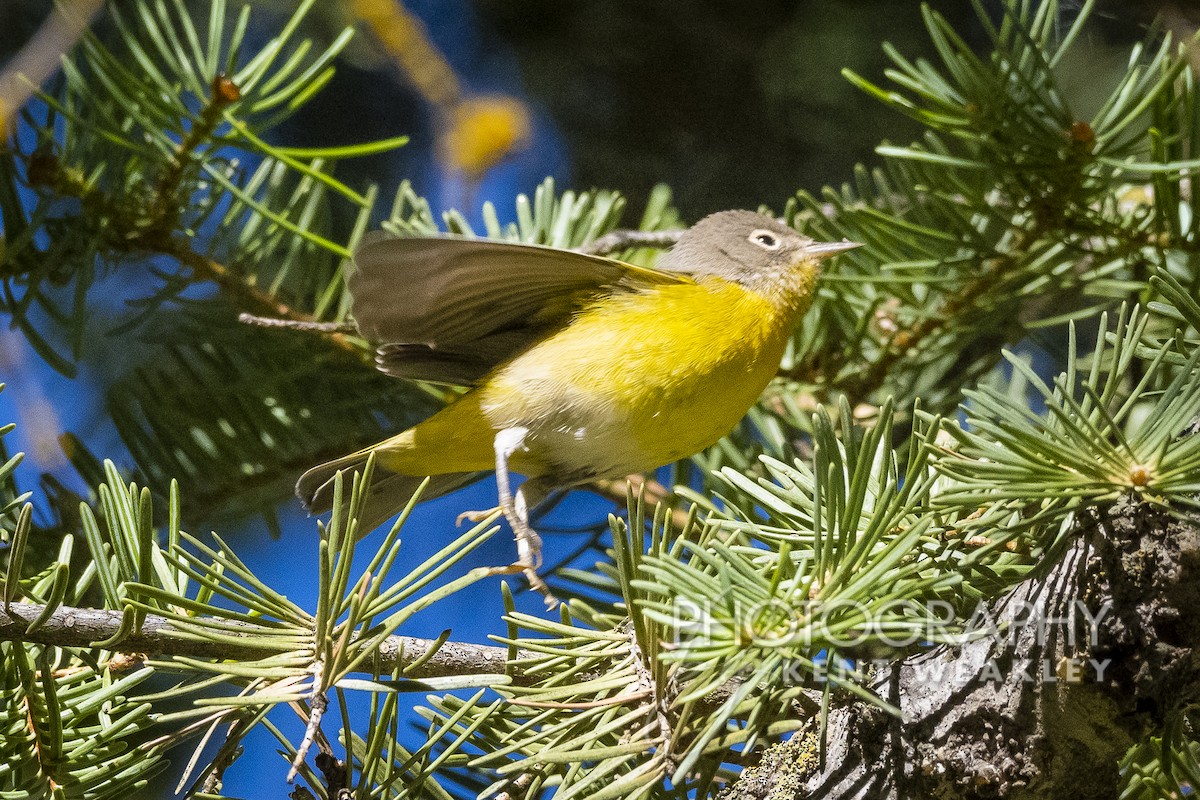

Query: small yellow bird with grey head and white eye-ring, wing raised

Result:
[296,211,858,606]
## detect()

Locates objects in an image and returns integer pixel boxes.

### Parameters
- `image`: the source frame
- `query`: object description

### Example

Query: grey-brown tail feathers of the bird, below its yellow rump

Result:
[296,450,485,536]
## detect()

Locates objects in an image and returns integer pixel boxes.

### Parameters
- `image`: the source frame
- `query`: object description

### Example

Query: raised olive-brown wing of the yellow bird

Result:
[349,236,691,385]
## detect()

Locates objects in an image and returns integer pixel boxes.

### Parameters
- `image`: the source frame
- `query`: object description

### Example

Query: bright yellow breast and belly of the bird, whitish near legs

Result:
[379,278,794,483]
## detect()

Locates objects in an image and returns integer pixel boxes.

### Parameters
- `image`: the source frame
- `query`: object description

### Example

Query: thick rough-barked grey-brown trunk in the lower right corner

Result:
[727,501,1200,800]
